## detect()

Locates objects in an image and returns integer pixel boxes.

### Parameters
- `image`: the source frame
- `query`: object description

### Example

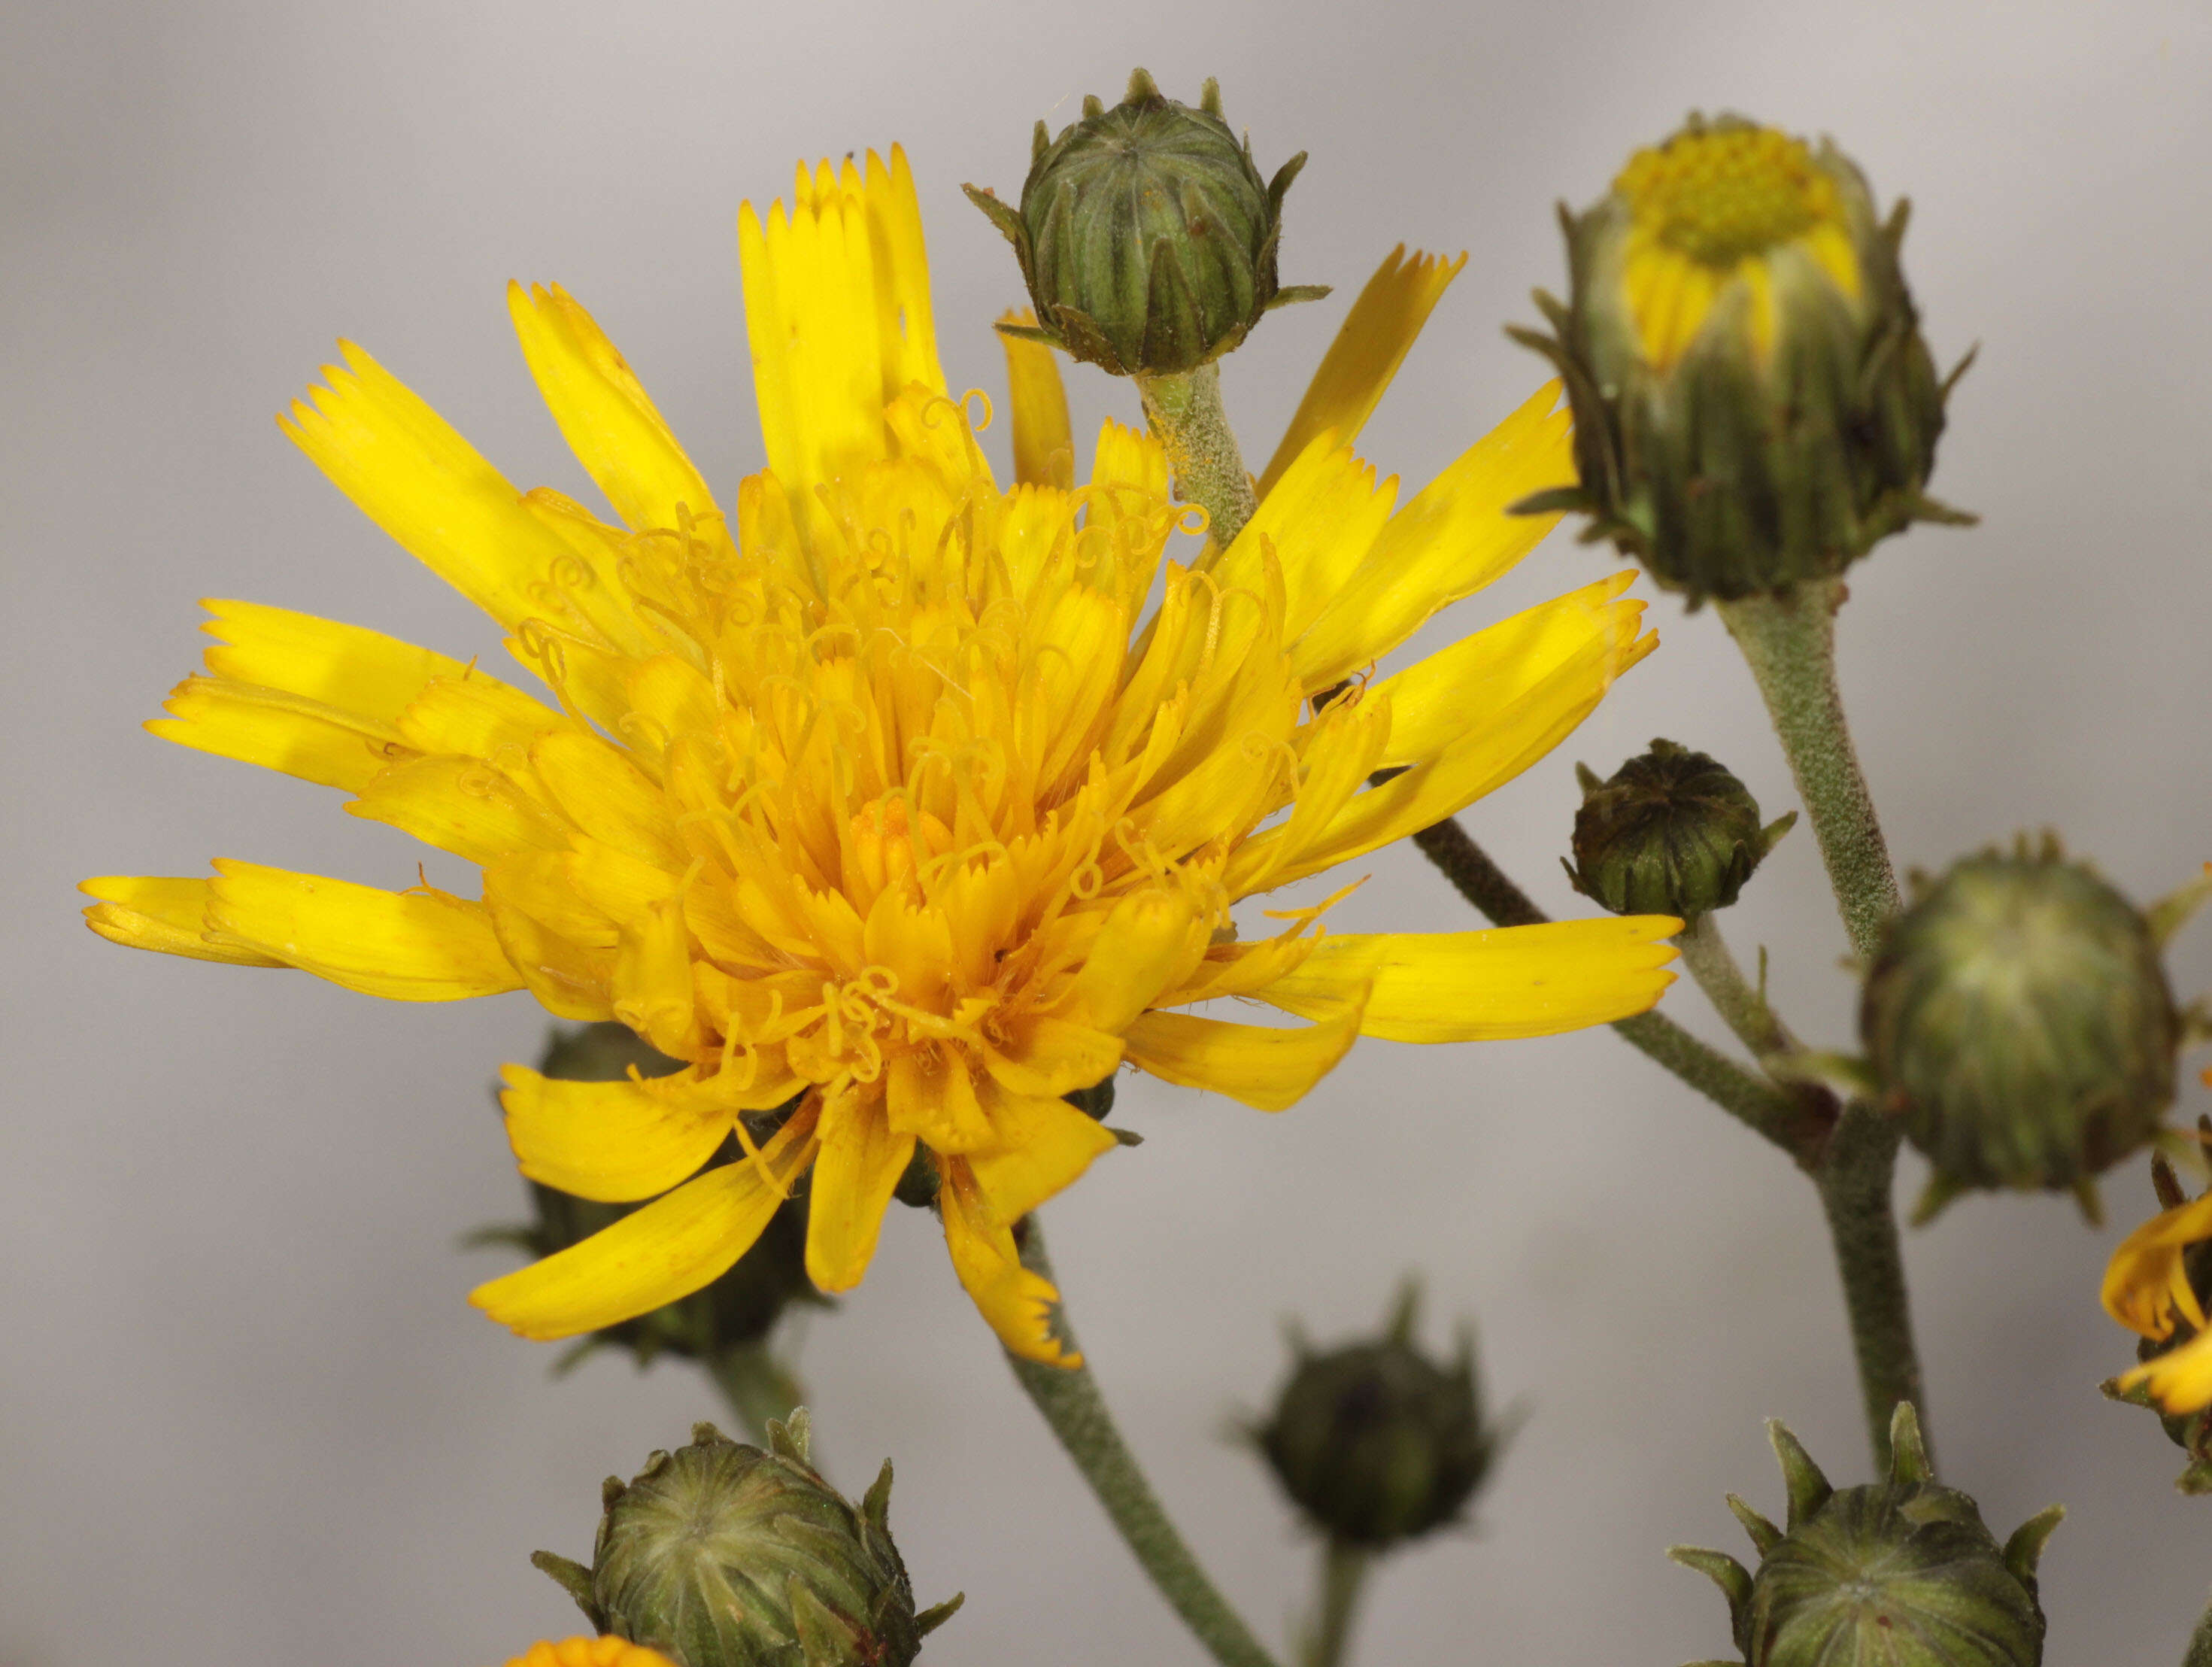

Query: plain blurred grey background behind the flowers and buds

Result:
[0,0,2212,1667]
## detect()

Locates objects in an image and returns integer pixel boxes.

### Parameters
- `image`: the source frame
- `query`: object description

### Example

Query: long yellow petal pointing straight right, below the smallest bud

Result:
[1252,914,1681,1043]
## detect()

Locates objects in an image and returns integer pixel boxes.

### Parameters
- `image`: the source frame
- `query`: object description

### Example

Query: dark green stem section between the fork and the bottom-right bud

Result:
[1819,1105,1933,1470]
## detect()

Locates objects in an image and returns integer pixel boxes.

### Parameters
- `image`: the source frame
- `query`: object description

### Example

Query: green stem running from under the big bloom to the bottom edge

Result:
[1006,1216,1276,1667]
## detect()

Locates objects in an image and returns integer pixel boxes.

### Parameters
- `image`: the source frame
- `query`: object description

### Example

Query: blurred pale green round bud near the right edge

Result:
[1858,839,2181,1220]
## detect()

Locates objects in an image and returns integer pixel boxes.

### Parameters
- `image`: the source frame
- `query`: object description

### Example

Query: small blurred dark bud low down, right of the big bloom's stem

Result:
[1250,1286,1502,1547]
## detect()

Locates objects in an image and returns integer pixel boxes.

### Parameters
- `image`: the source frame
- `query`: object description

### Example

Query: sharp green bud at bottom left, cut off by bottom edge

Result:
[531,1408,960,1667]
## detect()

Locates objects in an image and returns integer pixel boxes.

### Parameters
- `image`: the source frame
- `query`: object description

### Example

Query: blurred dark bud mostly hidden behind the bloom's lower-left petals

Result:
[475,1023,832,1363]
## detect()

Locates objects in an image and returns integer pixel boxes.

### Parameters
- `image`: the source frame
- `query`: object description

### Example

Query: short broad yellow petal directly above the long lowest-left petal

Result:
[500,1065,736,1204]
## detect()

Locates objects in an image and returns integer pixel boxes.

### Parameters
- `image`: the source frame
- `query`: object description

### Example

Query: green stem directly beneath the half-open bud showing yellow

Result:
[1719,580,1898,961]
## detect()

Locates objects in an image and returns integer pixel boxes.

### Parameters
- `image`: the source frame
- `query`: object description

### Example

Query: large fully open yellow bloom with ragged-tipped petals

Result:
[86,148,1674,1364]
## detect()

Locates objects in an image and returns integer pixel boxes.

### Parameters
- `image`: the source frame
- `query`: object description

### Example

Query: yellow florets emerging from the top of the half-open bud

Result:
[1613,117,1865,372]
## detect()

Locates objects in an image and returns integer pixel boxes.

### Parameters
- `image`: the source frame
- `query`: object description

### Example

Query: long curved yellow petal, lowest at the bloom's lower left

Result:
[469,1105,818,1341]
